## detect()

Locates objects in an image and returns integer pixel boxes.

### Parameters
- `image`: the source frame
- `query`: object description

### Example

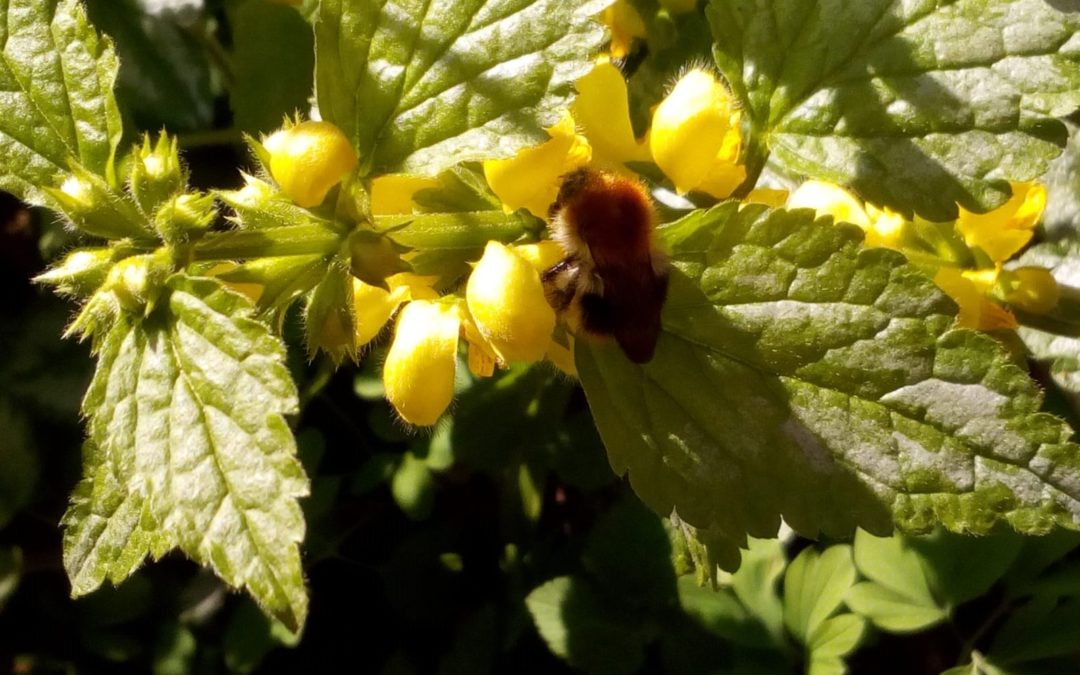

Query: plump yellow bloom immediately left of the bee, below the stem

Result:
[465,242,555,363]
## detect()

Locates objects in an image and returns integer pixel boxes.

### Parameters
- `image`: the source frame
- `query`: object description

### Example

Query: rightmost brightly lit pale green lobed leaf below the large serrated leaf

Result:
[845,530,948,633]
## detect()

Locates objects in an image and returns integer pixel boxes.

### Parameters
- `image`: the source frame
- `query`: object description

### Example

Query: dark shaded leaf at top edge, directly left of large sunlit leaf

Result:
[229,0,315,133]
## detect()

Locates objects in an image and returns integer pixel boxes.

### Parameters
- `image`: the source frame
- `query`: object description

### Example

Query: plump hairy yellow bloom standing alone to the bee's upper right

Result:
[649,69,745,194]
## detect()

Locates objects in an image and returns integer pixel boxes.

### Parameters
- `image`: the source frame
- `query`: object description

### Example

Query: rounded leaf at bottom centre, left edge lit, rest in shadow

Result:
[525,577,645,675]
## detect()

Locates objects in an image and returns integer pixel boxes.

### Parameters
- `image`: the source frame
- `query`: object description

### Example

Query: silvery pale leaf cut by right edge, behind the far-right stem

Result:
[1018,236,1080,395]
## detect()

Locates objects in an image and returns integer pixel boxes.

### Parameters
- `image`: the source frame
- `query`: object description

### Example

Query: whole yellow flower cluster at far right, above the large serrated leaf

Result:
[787,180,1059,330]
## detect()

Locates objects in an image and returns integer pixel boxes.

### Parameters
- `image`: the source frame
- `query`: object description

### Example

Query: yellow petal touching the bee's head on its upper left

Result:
[484,112,592,218]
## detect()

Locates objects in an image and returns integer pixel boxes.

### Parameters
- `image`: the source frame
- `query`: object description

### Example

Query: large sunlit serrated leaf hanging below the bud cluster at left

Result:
[64,275,308,631]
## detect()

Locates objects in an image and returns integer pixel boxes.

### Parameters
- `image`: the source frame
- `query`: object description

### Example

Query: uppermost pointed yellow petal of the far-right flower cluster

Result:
[956,183,1047,262]
